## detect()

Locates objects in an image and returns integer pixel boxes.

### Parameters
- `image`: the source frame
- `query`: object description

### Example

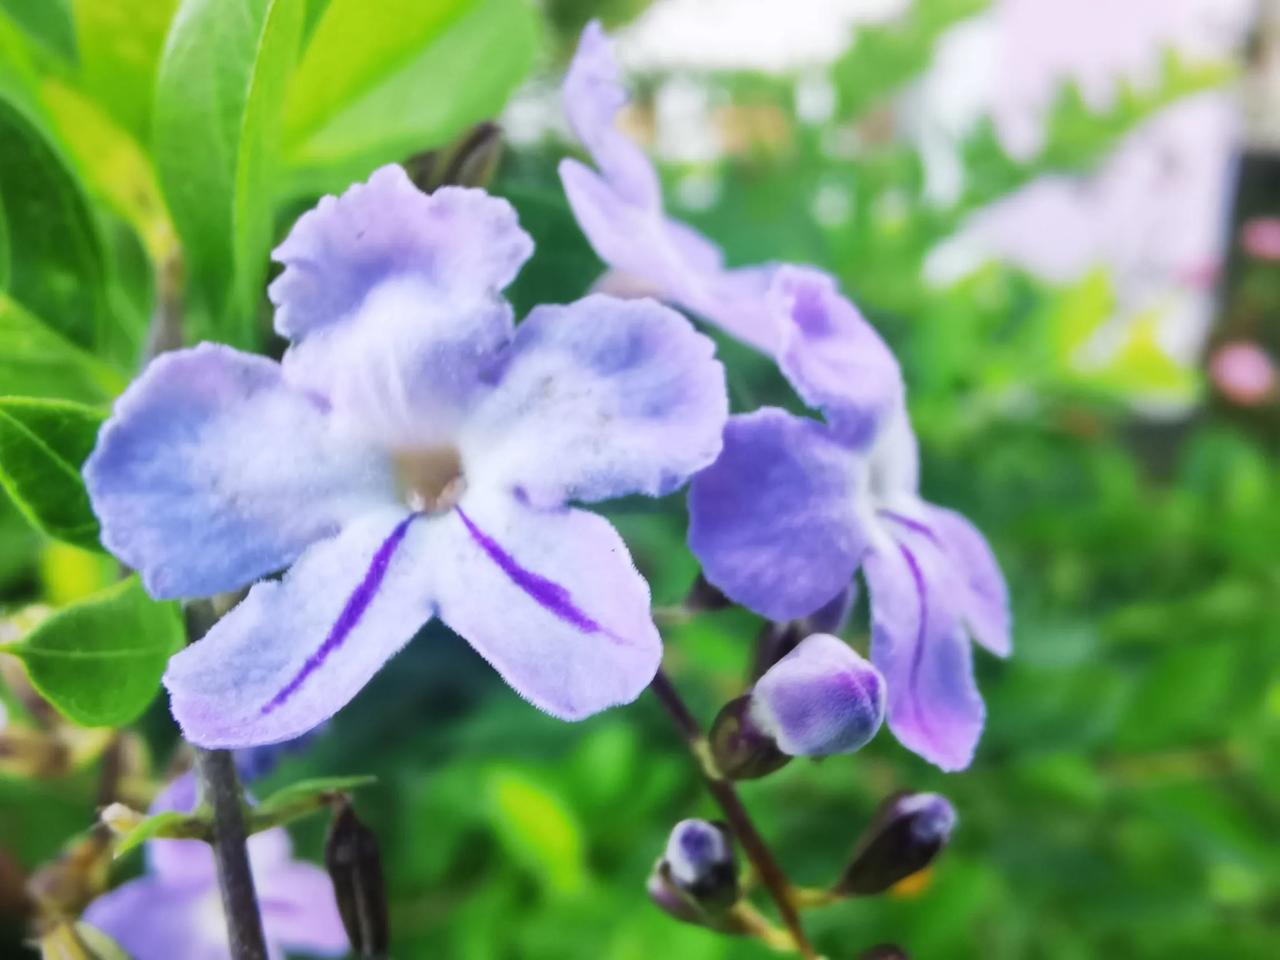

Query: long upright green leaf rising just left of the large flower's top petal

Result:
[155,0,302,346]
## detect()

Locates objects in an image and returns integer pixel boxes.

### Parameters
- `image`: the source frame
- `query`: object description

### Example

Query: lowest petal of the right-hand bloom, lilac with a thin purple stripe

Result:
[863,531,986,771]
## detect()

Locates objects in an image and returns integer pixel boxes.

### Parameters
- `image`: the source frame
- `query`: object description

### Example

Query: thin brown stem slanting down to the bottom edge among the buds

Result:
[649,669,818,960]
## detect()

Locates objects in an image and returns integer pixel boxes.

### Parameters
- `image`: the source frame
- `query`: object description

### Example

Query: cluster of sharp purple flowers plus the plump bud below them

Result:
[84,24,1010,769]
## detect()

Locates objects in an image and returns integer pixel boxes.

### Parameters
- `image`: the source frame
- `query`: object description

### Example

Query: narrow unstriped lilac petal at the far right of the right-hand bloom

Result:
[925,504,1014,657]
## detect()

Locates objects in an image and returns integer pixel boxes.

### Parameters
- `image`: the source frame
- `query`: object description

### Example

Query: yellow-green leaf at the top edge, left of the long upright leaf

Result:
[72,0,178,143]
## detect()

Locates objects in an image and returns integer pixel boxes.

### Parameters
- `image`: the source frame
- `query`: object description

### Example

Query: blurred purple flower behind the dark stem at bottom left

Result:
[84,774,347,960]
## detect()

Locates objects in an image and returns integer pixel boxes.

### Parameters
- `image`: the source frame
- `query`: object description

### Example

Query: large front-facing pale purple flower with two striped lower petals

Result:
[84,166,727,748]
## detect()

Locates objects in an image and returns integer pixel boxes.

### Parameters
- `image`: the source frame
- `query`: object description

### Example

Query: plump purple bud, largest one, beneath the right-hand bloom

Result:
[749,634,884,756]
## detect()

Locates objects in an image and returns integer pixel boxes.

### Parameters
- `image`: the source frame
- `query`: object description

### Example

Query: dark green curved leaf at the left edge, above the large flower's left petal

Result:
[0,90,109,350]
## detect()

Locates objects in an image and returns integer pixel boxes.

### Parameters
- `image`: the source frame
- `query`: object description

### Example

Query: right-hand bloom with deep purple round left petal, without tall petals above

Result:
[689,270,1010,769]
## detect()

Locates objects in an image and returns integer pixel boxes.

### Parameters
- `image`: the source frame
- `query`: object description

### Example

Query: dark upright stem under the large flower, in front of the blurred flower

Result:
[196,746,266,960]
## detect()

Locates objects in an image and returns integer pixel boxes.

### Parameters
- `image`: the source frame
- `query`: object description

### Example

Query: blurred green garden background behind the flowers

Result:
[0,0,1280,960]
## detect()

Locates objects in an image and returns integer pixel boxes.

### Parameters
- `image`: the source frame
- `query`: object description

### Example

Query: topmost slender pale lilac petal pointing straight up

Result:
[563,20,662,207]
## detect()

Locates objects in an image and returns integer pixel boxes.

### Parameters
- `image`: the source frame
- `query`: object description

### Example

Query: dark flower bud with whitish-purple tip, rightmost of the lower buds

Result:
[836,794,956,896]
